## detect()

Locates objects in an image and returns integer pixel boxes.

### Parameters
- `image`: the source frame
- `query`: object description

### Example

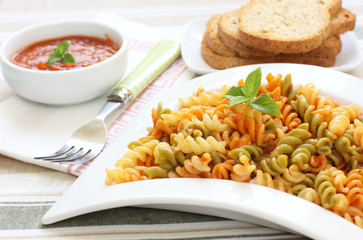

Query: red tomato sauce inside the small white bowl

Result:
[10,35,120,71]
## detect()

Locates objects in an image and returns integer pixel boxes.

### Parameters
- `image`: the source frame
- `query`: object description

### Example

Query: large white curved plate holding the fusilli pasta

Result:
[42,63,363,239]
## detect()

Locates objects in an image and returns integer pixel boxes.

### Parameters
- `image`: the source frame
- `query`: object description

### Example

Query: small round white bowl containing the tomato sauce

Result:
[0,20,128,105]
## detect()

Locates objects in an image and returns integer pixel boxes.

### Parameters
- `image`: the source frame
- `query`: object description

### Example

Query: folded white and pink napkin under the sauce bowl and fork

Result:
[0,14,194,176]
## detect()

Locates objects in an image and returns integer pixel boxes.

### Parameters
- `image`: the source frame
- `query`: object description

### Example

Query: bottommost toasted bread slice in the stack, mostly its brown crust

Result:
[201,35,335,69]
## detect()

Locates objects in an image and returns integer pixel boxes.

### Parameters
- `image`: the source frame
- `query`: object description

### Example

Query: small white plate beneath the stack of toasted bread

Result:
[181,18,362,74]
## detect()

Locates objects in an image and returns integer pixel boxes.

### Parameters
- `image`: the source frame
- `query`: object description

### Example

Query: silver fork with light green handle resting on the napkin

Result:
[34,40,180,163]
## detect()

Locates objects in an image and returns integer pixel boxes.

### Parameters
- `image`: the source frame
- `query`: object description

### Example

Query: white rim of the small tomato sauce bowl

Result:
[0,19,128,75]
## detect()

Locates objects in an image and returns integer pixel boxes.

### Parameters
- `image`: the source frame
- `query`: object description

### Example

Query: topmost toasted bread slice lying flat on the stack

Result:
[238,0,331,53]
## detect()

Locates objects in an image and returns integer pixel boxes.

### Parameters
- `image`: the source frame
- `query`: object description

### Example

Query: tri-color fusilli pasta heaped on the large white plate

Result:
[105,71,363,228]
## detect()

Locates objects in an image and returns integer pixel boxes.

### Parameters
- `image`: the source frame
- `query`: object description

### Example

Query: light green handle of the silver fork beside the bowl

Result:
[107,40,180,101]
